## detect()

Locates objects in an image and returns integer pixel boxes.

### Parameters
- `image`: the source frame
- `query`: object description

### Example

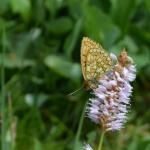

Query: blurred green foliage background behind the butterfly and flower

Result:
[0,0,150,150]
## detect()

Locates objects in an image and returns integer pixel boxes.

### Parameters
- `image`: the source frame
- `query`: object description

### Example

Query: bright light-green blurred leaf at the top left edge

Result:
[11,0,31,20]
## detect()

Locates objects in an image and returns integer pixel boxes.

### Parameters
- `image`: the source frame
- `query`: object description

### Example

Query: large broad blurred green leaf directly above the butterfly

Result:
[83,5,120,47]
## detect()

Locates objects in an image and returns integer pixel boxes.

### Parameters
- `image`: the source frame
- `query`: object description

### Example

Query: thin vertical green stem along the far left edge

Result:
[1,23,6,150]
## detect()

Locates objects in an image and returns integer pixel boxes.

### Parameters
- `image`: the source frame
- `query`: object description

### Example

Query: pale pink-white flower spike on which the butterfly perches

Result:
[87,52,136,131]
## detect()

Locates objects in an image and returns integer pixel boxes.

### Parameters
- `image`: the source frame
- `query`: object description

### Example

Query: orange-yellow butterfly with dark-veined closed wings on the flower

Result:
[81,37,112,89]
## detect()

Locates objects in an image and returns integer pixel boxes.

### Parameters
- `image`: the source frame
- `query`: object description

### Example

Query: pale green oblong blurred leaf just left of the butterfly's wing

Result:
[44,55,81,82]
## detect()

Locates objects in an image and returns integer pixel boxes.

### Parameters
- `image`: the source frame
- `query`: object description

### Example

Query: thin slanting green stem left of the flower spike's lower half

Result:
[74,103,86,150]
